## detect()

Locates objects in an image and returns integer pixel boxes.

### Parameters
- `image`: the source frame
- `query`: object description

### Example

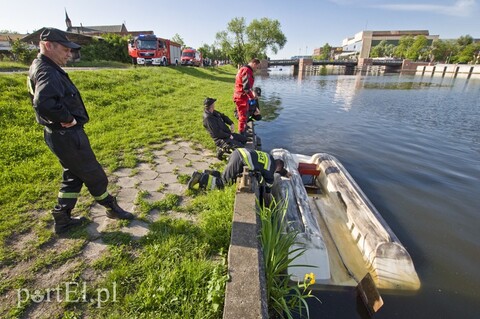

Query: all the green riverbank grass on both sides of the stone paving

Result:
[0,65,235,318]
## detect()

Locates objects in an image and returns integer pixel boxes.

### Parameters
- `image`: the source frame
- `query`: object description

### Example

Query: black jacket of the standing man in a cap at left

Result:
[28,53,89,130]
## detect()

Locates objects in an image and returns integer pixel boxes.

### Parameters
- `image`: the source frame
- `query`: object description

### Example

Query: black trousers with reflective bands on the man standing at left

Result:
[44,127,108,209]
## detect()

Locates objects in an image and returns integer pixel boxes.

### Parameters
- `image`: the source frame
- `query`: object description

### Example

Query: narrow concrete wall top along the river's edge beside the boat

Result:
[223,122,268,319]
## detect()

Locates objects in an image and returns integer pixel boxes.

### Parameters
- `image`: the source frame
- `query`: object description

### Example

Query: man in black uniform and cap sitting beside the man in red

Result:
[203,97,247,160]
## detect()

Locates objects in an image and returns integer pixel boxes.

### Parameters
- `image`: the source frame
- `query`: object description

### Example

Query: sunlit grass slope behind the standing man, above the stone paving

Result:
[0,68,234,245]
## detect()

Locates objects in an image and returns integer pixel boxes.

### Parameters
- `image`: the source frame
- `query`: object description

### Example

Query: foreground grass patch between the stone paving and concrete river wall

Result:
[90,187,235,318]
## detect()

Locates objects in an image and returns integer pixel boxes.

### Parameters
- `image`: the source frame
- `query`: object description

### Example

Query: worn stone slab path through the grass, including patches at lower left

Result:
[8,140,222,318]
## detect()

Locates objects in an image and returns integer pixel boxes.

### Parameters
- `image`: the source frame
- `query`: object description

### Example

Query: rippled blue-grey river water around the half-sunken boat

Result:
[255,70,480,318]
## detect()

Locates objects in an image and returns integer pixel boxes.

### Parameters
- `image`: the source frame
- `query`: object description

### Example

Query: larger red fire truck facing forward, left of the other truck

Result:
[128,34,181,65]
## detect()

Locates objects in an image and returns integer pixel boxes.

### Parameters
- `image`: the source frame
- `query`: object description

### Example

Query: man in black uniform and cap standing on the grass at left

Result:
[27,28,134,233]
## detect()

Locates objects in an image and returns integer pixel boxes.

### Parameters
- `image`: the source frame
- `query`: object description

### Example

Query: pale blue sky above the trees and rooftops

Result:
[0,0,480,58]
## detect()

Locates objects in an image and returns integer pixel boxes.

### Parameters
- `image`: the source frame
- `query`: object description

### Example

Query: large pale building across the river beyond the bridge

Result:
[342,30,439,58]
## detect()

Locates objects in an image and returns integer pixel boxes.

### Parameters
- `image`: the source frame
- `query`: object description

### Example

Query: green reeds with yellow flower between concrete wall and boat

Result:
[259,200,317,319]
